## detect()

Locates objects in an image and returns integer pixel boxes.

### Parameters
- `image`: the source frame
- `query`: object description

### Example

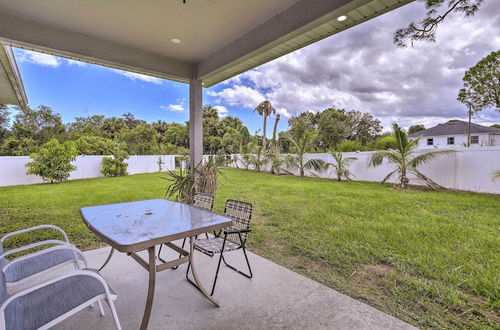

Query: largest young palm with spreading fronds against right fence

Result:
[369,123,455,189]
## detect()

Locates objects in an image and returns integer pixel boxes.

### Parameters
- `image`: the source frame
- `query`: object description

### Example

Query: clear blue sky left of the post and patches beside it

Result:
[14,49,287,134]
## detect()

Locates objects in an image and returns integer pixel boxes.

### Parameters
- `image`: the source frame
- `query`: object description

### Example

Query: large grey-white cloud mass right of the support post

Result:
[208,0,500,127]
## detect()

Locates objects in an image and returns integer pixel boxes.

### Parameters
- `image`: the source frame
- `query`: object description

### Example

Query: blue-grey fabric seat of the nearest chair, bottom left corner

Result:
[5,269,114,330]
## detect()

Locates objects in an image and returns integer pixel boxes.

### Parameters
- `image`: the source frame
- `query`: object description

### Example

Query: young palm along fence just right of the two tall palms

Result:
[285,131,325,177]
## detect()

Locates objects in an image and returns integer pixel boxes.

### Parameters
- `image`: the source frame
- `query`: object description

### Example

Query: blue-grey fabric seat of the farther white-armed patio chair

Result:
[4,249,83,283]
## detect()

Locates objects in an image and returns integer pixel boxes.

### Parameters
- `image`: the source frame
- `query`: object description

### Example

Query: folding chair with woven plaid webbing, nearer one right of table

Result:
[186,199,253,295]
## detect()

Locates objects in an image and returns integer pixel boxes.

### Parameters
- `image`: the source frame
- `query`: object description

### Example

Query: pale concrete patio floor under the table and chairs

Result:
[24,244,413,329]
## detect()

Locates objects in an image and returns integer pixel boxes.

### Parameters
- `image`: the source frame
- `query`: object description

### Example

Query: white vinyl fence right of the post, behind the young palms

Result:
[232,147,500,194]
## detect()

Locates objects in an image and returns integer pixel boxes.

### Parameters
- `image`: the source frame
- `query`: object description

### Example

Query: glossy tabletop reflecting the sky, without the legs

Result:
[80,199,231,252]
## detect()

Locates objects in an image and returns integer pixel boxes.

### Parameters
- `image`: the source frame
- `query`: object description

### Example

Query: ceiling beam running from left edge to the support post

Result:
[0,11,194,83]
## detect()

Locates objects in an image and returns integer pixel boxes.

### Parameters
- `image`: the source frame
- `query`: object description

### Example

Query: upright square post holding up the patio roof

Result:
[189,79,203,171]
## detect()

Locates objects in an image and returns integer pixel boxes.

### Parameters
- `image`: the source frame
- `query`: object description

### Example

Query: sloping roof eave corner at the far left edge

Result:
[0,44,28,106]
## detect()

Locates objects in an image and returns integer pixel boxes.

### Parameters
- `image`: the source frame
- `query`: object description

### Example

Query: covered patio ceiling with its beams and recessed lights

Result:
[0,0,413,87]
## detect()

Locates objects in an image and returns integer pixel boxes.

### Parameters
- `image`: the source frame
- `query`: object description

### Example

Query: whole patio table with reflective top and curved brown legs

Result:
[80,199,232,330]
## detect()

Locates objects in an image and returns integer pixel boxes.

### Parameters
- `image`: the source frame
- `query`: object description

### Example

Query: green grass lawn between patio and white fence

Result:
[0,169,500,328]
